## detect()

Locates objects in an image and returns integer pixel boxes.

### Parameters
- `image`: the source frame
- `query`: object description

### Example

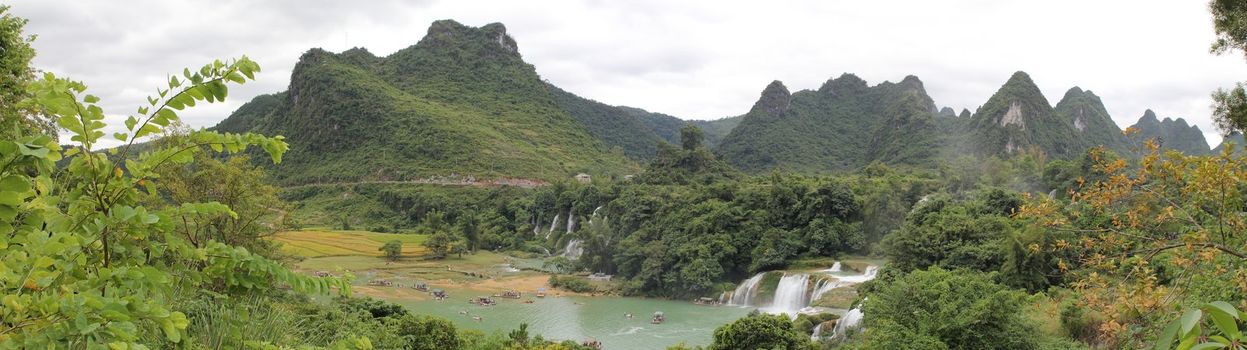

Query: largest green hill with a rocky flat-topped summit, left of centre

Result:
[216,20,633,184]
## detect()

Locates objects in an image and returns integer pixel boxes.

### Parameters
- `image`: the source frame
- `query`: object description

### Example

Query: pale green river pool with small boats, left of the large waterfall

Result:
[399,291,753,349]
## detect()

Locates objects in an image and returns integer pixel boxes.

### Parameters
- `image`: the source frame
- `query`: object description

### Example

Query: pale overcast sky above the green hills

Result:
[7,0,1247,146]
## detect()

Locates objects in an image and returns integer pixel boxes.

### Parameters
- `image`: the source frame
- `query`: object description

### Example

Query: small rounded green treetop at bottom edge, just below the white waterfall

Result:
[708,311,816,350]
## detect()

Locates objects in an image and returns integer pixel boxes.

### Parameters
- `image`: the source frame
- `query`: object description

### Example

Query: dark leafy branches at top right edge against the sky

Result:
[1208,0,1247,133]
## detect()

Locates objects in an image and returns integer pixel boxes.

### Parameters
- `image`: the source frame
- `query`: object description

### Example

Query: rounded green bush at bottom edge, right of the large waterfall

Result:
[859,268,1039,349]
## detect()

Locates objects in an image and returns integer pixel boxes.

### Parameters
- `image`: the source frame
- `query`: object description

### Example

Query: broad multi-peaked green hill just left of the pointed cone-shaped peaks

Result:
[718,73,939,172]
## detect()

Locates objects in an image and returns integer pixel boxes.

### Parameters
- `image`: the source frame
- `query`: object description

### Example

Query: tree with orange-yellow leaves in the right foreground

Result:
[1019,141,1247,348]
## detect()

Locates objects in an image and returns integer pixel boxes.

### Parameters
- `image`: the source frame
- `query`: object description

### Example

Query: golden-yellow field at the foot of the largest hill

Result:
[273,230,428,258]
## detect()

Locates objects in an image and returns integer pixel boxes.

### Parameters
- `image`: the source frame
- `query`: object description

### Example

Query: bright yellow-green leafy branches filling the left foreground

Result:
[0,57,349,349]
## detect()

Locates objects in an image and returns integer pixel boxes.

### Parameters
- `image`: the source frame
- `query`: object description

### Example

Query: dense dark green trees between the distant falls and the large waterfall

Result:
[593,174,865,296]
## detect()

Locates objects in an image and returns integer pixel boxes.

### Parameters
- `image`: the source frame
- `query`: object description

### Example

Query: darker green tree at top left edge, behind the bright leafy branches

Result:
[0,5,56,138]
